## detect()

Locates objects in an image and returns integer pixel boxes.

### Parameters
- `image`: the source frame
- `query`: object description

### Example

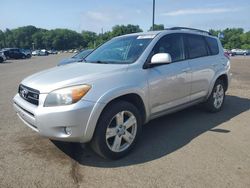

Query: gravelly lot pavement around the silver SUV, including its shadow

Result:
[0,54,250,188]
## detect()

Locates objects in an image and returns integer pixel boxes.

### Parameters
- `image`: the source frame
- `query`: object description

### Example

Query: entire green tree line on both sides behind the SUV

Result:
[0,24,250,50]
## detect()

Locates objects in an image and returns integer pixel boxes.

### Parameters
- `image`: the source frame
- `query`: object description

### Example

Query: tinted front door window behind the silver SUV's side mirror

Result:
[152,34,185,62]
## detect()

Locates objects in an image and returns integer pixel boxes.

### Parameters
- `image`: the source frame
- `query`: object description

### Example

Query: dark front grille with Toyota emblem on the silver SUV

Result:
[18,84,40,106]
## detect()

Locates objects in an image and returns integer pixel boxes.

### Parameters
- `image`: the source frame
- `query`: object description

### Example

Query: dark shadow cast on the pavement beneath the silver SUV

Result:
[52,96,250,168]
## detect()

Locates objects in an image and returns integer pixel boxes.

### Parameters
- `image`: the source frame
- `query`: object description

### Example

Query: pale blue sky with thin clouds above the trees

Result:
[0,0,250,33]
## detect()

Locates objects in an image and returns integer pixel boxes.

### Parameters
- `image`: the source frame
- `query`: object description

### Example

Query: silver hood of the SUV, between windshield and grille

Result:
[22,63,128,93]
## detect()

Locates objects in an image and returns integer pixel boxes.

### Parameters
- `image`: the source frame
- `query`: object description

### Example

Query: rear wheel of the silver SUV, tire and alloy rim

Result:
[205,79,225,112]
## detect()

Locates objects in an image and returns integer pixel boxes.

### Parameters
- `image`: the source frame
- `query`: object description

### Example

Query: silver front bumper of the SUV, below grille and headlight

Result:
[13,94,101,142]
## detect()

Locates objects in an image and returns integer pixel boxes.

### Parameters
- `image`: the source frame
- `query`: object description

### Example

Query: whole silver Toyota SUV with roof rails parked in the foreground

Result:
[13,27,230,159]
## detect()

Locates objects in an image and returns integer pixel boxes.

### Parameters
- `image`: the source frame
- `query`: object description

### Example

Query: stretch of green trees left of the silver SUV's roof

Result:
[0,24,142,50]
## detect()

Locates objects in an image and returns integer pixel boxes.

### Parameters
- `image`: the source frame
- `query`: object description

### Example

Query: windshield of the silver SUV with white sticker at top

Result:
[85,35,153,64]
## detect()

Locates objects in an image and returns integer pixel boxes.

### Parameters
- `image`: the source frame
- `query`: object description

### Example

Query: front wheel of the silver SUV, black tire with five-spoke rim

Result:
[91,101,142,159]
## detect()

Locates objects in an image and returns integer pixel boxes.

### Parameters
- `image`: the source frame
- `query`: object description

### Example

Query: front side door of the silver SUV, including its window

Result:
[147,34,191,116]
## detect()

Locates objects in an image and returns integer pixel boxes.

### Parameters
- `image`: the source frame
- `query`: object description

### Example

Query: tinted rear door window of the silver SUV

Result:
[187,35,208,58]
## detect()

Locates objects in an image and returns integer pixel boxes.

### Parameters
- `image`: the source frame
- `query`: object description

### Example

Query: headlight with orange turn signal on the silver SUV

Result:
[44,85,91,107]
